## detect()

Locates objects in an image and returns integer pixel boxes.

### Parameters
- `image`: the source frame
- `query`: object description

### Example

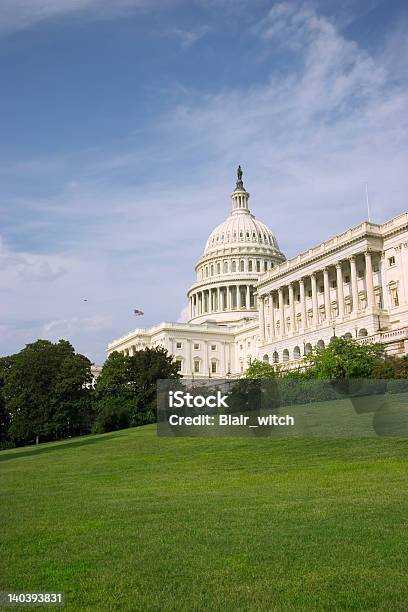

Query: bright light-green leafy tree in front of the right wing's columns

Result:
[308,337,384,380]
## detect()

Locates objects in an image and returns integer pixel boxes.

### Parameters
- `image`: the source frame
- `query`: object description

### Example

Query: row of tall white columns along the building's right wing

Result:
[259,251,375,343]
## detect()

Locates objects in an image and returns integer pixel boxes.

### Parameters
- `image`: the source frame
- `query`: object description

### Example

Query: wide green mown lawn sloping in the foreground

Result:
[0,426,408,611]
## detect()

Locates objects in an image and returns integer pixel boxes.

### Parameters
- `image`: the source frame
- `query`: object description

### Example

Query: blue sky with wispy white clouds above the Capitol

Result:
[0,0,408,362]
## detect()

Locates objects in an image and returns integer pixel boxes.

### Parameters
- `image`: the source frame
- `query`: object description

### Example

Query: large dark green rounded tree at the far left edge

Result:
[2,340,92,443]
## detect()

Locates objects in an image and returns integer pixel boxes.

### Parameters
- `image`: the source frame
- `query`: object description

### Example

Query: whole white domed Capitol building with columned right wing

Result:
[108,167,408,378]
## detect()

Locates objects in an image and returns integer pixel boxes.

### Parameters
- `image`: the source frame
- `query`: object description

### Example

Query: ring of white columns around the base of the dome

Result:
[189,285,255,319]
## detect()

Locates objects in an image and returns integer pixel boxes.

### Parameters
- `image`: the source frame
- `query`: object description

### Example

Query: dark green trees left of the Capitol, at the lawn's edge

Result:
[0,340,180,449]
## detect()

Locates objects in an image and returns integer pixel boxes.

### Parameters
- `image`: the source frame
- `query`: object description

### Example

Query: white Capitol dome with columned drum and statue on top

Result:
[188,166,285,324]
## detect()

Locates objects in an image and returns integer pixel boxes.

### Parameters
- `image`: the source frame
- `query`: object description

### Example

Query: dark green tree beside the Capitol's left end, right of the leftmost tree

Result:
[94,347,180,431]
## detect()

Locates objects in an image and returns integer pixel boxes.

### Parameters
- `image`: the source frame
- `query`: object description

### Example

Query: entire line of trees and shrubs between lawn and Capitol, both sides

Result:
[0,337,408,448]
